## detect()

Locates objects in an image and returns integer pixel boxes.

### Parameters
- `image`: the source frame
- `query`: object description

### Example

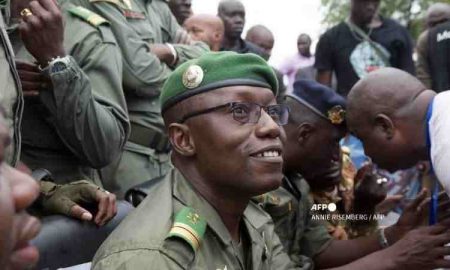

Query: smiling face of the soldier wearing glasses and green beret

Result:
[187,86,285,197]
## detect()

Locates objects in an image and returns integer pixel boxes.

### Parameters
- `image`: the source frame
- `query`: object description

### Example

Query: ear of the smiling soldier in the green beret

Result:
[168,123,195,157]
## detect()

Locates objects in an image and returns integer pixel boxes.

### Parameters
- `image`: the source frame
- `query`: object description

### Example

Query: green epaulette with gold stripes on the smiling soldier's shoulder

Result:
[167,207,206,251]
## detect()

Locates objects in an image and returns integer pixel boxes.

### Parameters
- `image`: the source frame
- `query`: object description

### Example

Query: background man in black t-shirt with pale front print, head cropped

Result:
[315,0,415,96]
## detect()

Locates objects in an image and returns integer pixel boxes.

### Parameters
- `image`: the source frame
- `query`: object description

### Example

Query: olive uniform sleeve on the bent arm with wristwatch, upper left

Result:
[41,29,129,168]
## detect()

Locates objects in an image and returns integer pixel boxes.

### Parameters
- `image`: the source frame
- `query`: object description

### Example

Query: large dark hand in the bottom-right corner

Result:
[383,219,450,270]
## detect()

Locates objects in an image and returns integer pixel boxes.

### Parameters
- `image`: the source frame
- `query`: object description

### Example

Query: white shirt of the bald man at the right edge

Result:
[428,91,450,195]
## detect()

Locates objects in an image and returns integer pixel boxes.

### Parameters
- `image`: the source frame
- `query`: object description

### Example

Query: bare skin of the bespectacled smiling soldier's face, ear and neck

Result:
[163,86,284,242]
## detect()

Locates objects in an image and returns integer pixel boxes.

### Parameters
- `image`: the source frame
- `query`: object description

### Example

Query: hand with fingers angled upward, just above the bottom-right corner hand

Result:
[386,189,430,244]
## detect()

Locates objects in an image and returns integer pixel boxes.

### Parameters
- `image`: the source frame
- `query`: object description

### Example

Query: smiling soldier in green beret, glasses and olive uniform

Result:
[93,52,300,270]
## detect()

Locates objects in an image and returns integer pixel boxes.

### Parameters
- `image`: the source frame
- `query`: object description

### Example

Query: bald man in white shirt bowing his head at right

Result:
[347,68,450,194]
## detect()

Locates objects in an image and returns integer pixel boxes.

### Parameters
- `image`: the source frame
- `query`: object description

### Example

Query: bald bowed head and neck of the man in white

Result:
[347,68,436,172]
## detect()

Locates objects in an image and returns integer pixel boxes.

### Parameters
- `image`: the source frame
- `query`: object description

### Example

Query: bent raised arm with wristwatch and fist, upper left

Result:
[20,0,129,168]
